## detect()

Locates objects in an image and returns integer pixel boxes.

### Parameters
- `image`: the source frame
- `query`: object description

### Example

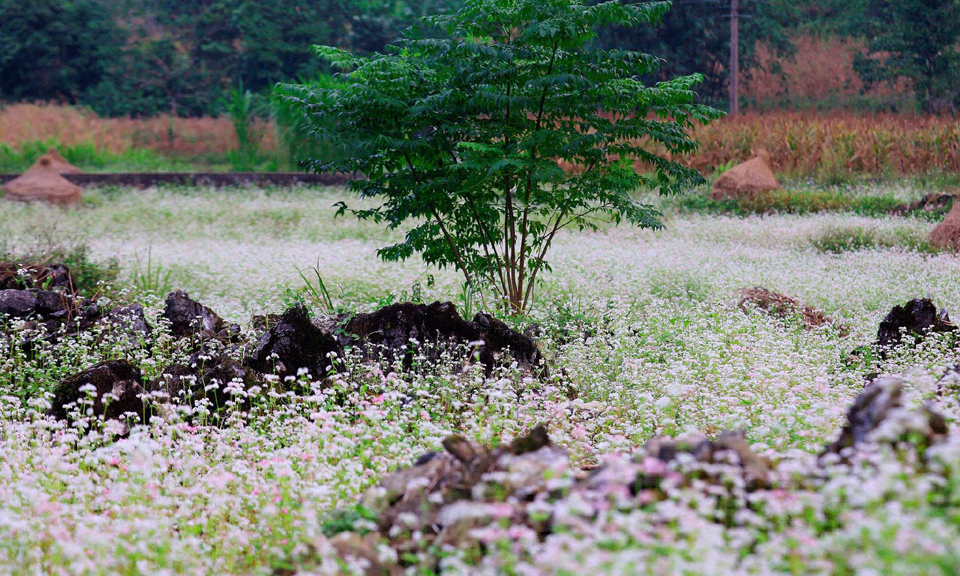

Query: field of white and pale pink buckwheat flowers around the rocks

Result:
[0,184,960,576]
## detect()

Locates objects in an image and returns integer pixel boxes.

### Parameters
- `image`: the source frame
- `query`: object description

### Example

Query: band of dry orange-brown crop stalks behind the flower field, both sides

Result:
[0,104,960,177]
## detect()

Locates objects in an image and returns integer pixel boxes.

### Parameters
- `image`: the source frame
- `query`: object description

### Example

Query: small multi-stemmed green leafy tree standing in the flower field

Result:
[279,0,719,313]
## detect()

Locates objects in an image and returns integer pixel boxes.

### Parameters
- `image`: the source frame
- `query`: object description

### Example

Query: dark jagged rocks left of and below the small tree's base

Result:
[26,289,546,419]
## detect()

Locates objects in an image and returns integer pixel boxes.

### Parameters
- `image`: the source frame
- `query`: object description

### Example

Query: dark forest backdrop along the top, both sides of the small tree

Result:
[0,0,960,117]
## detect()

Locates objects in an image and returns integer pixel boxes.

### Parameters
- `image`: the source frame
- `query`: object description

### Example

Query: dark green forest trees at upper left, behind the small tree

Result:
[0,0,453,116]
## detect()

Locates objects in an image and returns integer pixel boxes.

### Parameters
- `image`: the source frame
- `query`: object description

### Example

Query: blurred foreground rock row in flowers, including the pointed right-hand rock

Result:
[314,378,946,575]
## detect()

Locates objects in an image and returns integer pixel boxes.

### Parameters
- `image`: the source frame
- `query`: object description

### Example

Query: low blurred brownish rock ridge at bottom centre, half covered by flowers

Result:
[318,427,770,574]
